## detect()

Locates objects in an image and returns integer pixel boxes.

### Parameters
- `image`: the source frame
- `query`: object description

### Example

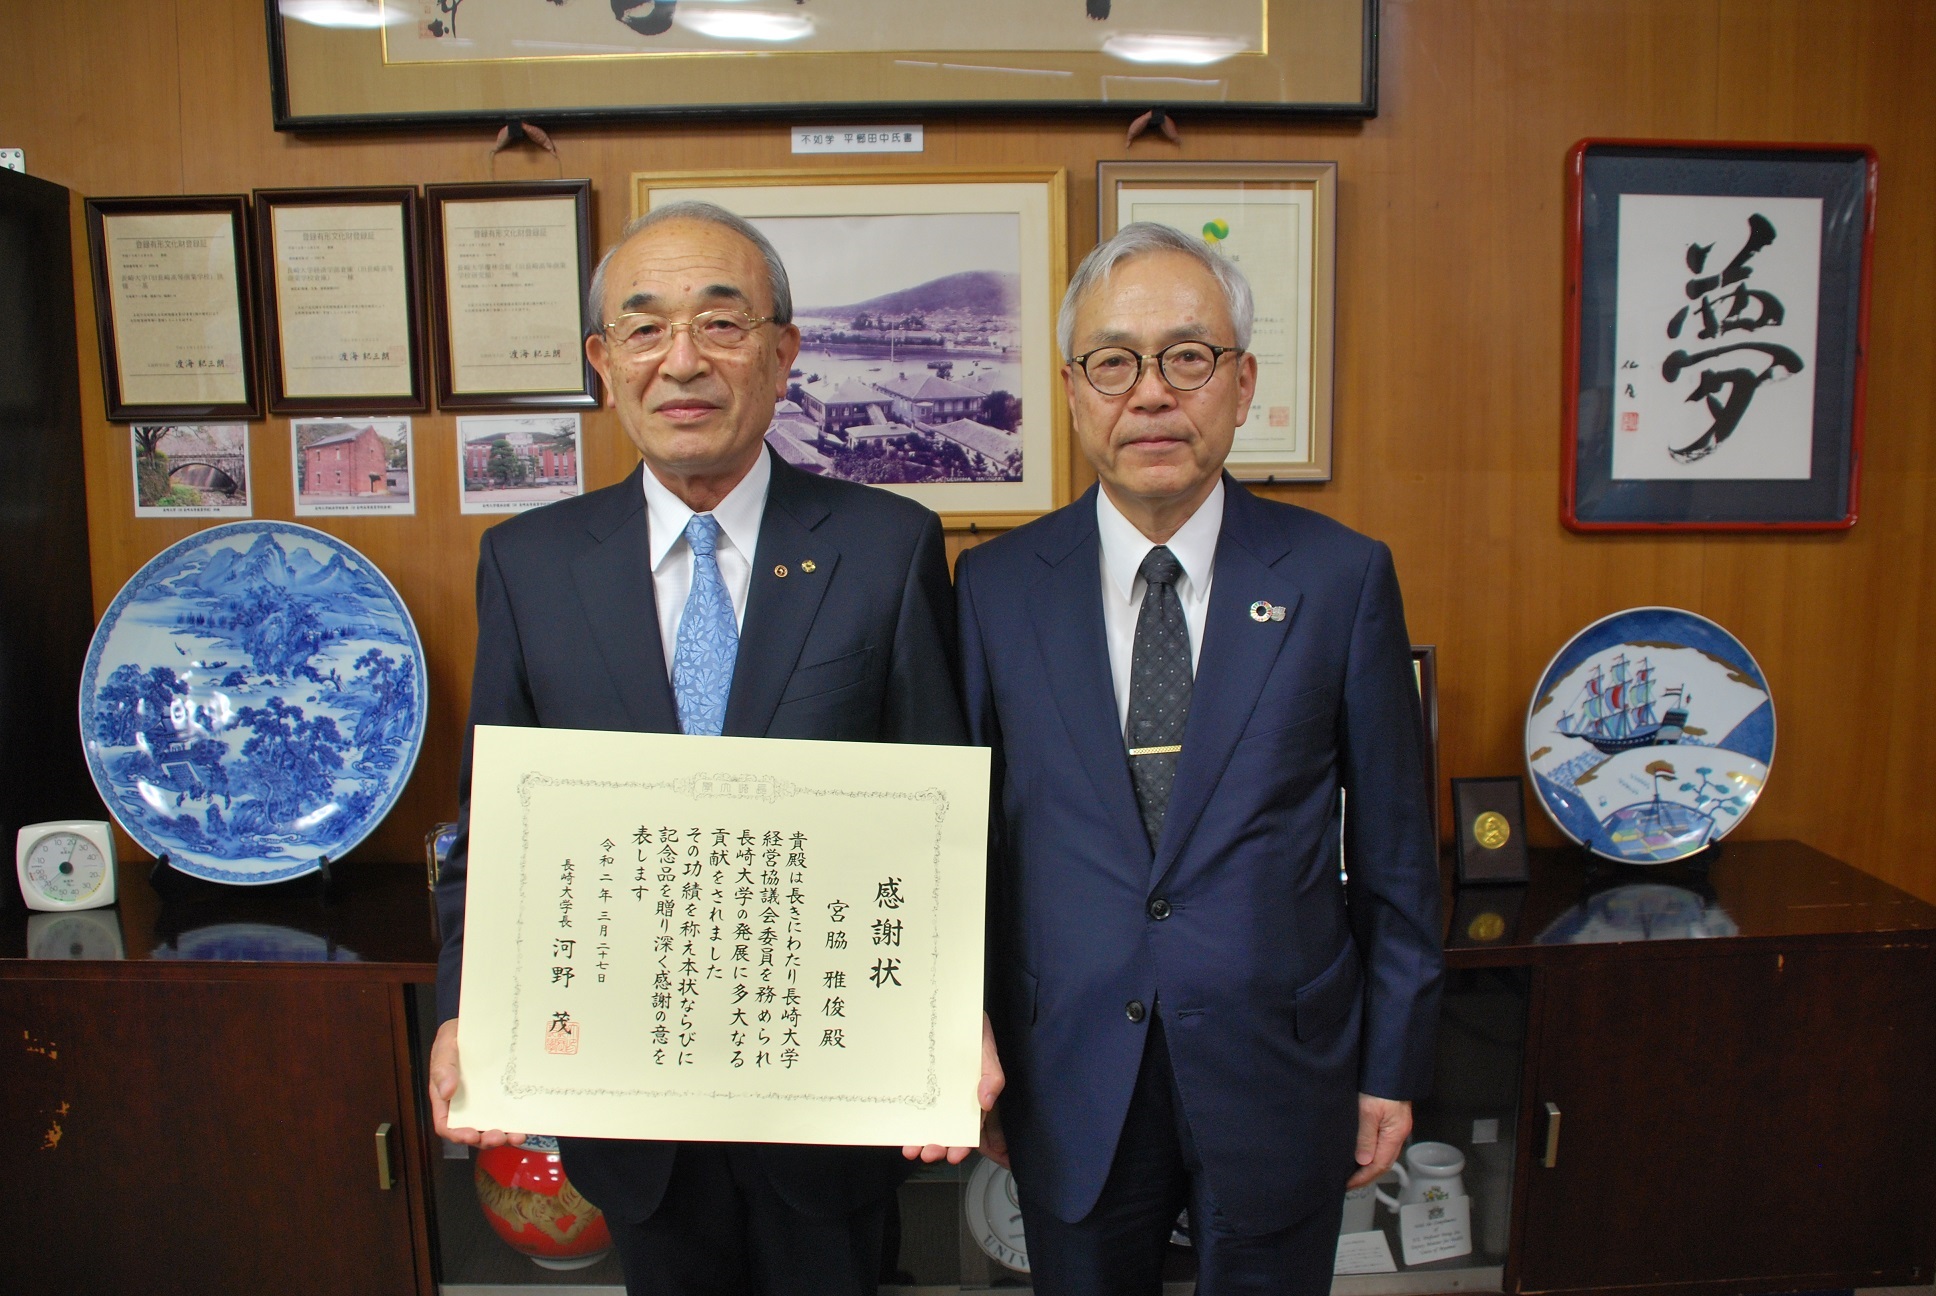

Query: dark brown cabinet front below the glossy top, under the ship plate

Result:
[1516,940,1936,1292]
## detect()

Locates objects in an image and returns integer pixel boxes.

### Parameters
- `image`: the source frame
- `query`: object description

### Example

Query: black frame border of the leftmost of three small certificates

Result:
[87,194,261,422]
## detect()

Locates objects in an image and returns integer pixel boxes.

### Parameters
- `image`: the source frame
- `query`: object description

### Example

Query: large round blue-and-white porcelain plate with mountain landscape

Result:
[81,521,430,883]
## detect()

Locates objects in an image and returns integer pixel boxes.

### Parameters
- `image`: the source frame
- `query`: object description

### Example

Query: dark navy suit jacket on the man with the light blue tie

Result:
[438,451,964,1220]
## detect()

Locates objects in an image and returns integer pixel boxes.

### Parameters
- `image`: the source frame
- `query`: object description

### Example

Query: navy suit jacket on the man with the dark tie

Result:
[956,477,1442,1234]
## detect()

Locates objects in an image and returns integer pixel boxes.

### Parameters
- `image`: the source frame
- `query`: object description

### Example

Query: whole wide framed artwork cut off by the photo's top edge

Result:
[263,0,1378,130]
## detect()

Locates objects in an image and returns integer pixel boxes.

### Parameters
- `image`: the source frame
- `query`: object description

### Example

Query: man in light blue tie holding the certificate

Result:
[430,203,1001,1296]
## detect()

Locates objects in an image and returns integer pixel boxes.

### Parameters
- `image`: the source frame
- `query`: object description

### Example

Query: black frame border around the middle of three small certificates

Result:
[256,186,430,417]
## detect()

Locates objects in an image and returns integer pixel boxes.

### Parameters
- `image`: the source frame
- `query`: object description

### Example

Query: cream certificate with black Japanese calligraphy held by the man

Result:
[451,725,989,1147]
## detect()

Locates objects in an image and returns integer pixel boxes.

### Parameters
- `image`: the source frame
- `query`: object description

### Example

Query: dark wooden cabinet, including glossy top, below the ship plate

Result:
[1446,843,1936,1292]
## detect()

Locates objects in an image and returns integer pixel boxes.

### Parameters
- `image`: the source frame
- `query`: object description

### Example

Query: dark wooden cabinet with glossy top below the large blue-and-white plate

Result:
[0,870,436,1296]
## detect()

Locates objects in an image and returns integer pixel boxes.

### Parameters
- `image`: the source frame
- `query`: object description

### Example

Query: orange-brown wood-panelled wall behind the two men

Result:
[0,0,1936,899]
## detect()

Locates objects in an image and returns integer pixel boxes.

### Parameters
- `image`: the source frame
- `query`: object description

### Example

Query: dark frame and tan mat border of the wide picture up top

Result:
[263,0,1380,132]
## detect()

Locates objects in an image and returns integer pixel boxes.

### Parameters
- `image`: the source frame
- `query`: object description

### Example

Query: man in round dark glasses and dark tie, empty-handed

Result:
[956,225,1442,1296]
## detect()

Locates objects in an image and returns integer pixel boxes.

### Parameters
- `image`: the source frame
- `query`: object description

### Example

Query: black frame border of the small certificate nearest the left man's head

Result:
[424,180,600,411]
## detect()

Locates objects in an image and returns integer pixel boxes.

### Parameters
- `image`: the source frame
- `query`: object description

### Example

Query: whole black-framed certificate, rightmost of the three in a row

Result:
[424,180,598,409]
